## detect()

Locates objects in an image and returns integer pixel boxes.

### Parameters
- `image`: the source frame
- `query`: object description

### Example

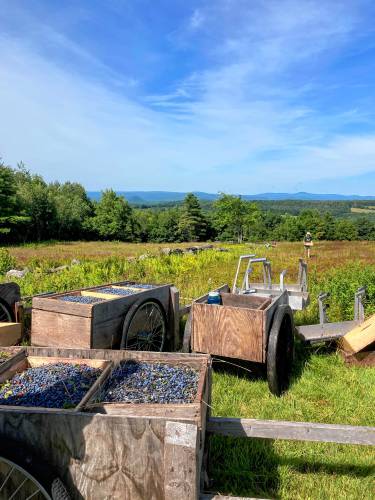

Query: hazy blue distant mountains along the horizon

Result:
[87,191,375,204]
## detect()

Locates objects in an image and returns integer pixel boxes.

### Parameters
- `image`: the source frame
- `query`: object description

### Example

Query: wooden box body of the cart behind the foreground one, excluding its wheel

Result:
[31,281,173,349]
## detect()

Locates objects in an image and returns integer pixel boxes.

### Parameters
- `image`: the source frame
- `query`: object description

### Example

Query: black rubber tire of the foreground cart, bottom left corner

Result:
[0,436,71,500]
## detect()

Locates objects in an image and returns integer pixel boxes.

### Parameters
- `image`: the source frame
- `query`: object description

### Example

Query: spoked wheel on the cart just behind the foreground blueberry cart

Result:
[121,299,167,352]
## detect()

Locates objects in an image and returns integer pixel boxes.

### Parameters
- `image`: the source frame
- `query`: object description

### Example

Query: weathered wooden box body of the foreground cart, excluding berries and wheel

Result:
[0,347,211,500]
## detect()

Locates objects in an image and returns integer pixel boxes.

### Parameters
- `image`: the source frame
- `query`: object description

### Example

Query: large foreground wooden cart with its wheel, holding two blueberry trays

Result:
[0,347,211,500]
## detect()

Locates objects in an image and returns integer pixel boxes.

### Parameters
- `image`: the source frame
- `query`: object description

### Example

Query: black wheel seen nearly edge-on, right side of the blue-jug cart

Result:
[267,305,294,396]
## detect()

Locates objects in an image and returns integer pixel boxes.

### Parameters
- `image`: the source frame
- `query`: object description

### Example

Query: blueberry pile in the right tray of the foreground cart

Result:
[98,361,199,403]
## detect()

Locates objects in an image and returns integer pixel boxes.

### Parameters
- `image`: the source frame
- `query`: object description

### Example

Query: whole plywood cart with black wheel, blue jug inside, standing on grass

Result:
[184,285,294,395]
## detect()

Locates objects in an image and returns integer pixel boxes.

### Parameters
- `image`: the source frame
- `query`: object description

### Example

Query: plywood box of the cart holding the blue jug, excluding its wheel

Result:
[191,291,288,363]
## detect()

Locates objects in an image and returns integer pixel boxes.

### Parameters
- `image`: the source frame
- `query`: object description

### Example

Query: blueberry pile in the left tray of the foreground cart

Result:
[0,362,102,408]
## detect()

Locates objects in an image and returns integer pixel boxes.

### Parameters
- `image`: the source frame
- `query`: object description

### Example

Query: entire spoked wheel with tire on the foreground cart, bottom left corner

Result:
[0,438,71,500]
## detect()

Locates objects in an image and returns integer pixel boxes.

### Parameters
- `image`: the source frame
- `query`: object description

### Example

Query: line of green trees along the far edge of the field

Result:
[0,162,375,243]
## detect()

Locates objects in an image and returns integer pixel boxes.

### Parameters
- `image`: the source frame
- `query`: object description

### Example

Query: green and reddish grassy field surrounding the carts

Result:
[2,242,375,499]
